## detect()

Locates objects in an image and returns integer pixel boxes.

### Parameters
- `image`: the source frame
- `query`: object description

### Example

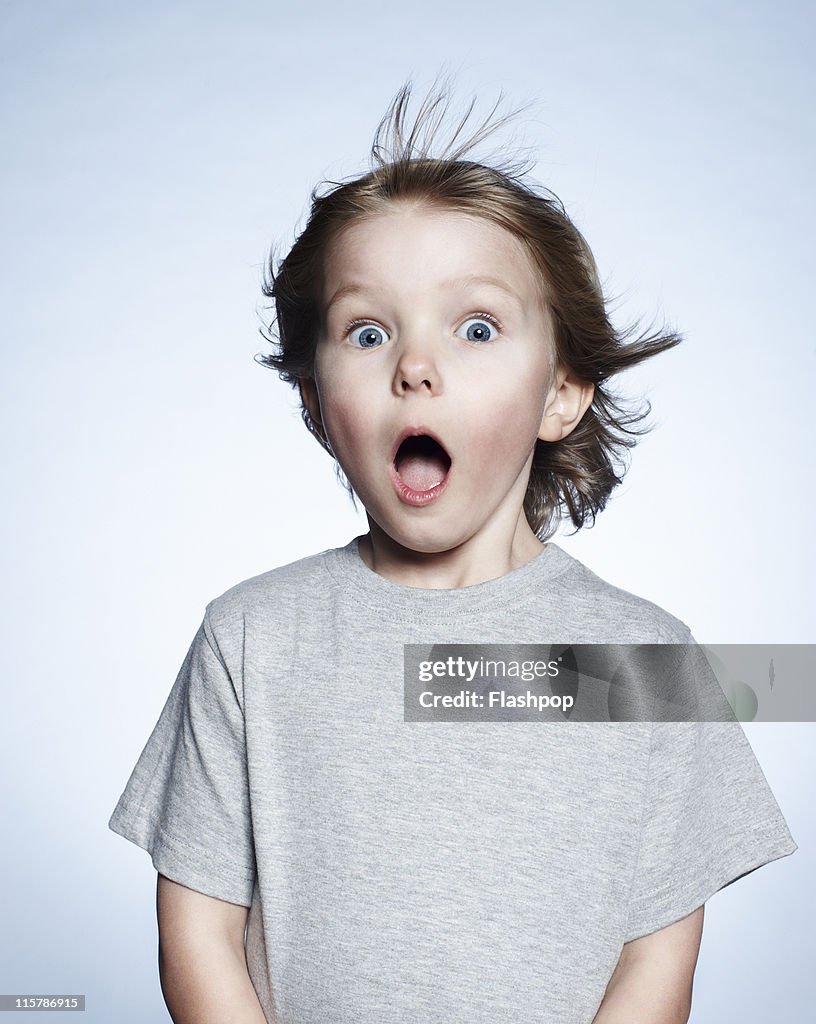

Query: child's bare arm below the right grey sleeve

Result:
[593,904,705,1024]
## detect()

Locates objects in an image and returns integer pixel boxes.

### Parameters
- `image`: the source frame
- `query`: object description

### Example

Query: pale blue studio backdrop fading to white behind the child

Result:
[0,0,816,1024]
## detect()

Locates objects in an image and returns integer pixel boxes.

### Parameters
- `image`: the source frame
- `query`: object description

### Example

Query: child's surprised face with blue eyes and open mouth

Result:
[302,205,584,552]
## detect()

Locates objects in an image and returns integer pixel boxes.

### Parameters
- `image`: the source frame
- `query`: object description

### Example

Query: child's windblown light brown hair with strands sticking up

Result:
[256,73,682,542]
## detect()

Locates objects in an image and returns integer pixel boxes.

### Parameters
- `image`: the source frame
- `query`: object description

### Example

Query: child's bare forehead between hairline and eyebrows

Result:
[325,206,539,304]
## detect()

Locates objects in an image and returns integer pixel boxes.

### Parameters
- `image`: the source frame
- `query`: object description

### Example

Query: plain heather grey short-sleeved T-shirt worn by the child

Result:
[110,538,798,1024]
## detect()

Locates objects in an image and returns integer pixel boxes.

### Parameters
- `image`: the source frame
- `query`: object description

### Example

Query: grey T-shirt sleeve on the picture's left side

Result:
[109,605,256,906]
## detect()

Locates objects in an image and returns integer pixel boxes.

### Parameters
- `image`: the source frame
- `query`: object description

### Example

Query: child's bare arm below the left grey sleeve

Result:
[156,873,266,1024]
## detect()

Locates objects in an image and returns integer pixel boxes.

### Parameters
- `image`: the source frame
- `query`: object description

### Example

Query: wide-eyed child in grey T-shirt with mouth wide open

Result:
[110,81,797,1024]
